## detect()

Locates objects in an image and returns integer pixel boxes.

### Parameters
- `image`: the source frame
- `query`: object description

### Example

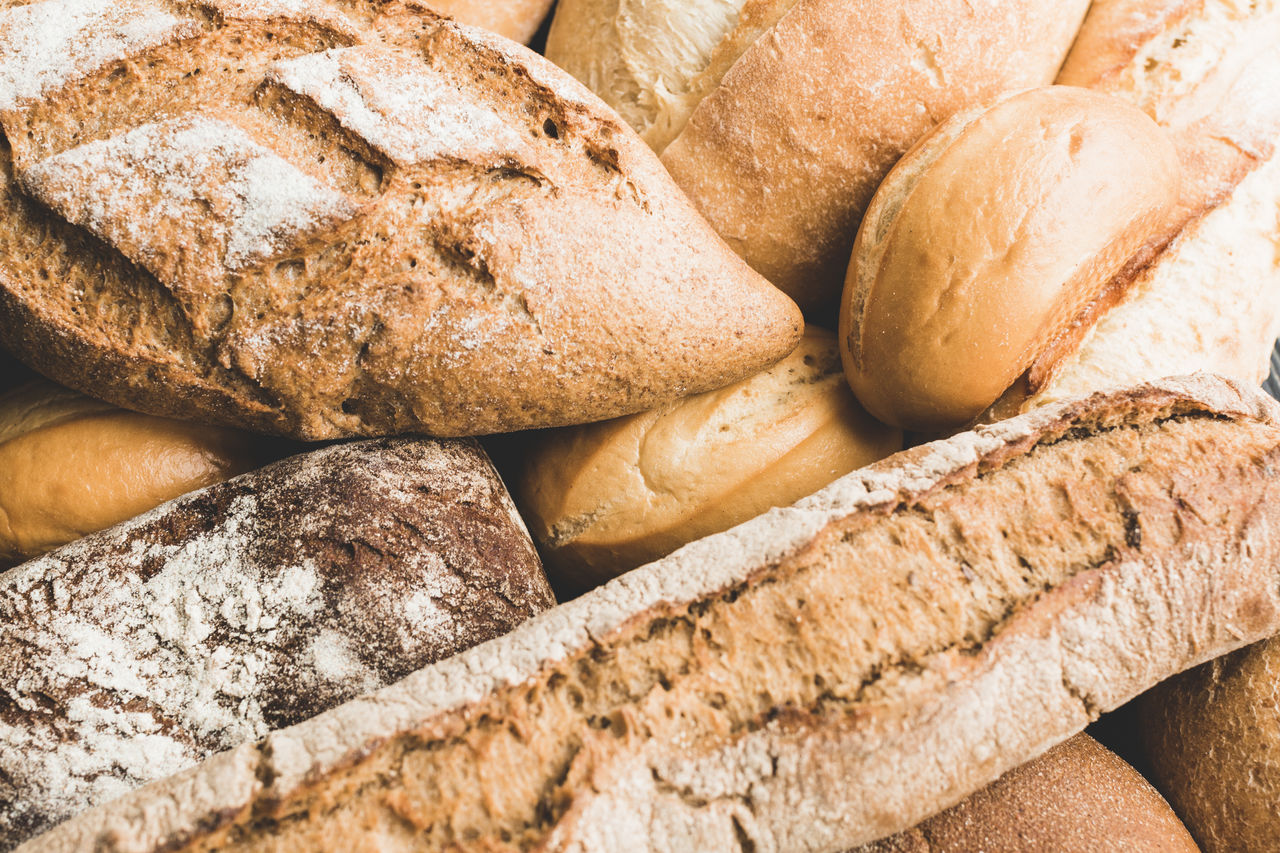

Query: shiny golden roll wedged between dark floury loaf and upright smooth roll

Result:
[513,327,902,594]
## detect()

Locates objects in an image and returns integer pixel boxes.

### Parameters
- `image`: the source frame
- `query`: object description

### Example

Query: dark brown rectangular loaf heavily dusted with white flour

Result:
[0,439,554,850]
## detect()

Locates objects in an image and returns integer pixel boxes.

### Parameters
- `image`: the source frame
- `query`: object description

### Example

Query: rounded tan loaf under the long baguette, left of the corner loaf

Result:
[858,734,1199,853]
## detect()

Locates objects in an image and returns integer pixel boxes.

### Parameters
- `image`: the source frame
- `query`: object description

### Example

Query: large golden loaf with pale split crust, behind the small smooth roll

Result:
[547,0,1089,312]
